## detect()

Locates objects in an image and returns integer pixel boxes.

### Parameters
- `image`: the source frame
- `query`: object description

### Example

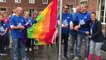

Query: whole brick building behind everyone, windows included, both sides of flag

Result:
[0,0,106,23]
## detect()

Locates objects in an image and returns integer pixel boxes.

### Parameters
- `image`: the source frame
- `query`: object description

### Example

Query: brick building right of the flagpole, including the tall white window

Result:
[63,0,106,24]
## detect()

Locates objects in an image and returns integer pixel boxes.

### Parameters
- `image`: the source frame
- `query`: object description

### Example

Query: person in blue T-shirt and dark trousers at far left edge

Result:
[0,15,8,56]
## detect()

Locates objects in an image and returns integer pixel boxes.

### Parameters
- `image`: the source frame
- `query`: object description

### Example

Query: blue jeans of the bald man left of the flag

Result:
[13,39,27,60]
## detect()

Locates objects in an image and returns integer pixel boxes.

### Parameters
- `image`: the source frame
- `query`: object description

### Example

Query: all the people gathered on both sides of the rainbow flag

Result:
[0,5,104,60]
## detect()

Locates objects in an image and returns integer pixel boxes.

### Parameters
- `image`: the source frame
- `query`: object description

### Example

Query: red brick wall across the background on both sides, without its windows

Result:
[0,0,97,13]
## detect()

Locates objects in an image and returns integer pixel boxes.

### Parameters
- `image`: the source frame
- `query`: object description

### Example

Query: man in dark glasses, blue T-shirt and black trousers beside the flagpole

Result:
[58,5,73,59]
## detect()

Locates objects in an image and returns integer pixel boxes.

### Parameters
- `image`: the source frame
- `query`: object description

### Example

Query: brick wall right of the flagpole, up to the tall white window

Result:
[63,0,98,11]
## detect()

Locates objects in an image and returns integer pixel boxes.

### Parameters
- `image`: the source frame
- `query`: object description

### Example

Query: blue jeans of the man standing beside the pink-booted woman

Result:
[76,33,89,58]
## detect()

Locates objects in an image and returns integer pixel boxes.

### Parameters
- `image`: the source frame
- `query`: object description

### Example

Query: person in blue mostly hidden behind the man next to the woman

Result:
[70,6,80,56]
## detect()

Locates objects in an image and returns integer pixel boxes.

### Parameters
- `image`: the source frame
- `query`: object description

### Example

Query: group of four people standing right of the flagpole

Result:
[58,5,104,60]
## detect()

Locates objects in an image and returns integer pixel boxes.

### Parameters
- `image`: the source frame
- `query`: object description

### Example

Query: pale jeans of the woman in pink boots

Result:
[89,40,103,56]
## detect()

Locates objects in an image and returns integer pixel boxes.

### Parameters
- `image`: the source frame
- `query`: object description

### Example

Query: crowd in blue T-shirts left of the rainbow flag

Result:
[0,7,40,60]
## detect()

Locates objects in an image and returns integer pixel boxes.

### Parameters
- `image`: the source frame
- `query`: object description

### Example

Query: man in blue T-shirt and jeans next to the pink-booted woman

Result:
[74,5,91,60]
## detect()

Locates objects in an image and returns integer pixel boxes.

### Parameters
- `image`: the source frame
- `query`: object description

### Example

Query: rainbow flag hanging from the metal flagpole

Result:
[27,0,58,45]
